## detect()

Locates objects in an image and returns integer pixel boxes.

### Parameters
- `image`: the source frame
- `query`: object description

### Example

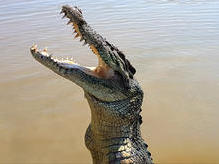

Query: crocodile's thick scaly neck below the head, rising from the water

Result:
[85,93,152,164]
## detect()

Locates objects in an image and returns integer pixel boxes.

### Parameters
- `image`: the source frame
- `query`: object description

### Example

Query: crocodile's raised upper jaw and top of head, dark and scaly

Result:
[61,6,135,88]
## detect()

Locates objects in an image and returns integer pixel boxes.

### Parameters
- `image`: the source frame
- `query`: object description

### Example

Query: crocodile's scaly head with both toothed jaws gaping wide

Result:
[30,6,141,102]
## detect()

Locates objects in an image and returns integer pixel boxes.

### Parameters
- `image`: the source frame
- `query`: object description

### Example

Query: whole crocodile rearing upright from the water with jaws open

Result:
[30,5,153,164]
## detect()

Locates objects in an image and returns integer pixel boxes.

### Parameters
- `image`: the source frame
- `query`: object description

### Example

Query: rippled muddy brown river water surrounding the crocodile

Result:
[0,0,219,164]
